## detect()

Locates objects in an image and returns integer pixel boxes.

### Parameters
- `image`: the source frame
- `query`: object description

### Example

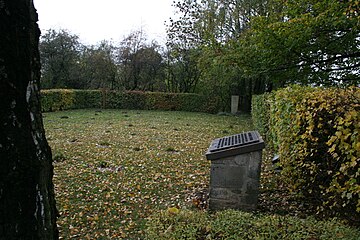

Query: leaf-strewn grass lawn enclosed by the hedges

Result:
[44,110,253,239]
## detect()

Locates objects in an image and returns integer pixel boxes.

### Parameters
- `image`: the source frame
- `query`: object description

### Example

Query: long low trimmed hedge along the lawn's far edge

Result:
[41,89,218,113]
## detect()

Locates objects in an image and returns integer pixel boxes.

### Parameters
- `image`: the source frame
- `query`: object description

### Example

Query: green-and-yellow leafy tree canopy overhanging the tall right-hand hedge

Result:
[239,0,360,85]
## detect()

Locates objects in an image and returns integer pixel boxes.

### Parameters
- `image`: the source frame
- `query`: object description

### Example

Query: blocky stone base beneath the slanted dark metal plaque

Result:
[209,151,262,211]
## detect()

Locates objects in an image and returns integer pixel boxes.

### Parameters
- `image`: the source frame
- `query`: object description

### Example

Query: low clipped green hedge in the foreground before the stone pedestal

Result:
[145,210,360,240]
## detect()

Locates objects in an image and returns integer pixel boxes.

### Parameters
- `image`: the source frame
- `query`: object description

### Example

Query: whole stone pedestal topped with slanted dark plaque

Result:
[206,131,265,211]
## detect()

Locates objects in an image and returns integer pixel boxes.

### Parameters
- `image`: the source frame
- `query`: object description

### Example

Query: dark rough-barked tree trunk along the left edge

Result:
[0,0,58,240]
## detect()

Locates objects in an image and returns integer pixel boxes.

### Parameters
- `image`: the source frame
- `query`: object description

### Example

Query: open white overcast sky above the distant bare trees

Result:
[34,0,175,44]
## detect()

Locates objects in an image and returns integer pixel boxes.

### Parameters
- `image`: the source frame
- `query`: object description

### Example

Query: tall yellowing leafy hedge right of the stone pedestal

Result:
[252,86,360,220]
